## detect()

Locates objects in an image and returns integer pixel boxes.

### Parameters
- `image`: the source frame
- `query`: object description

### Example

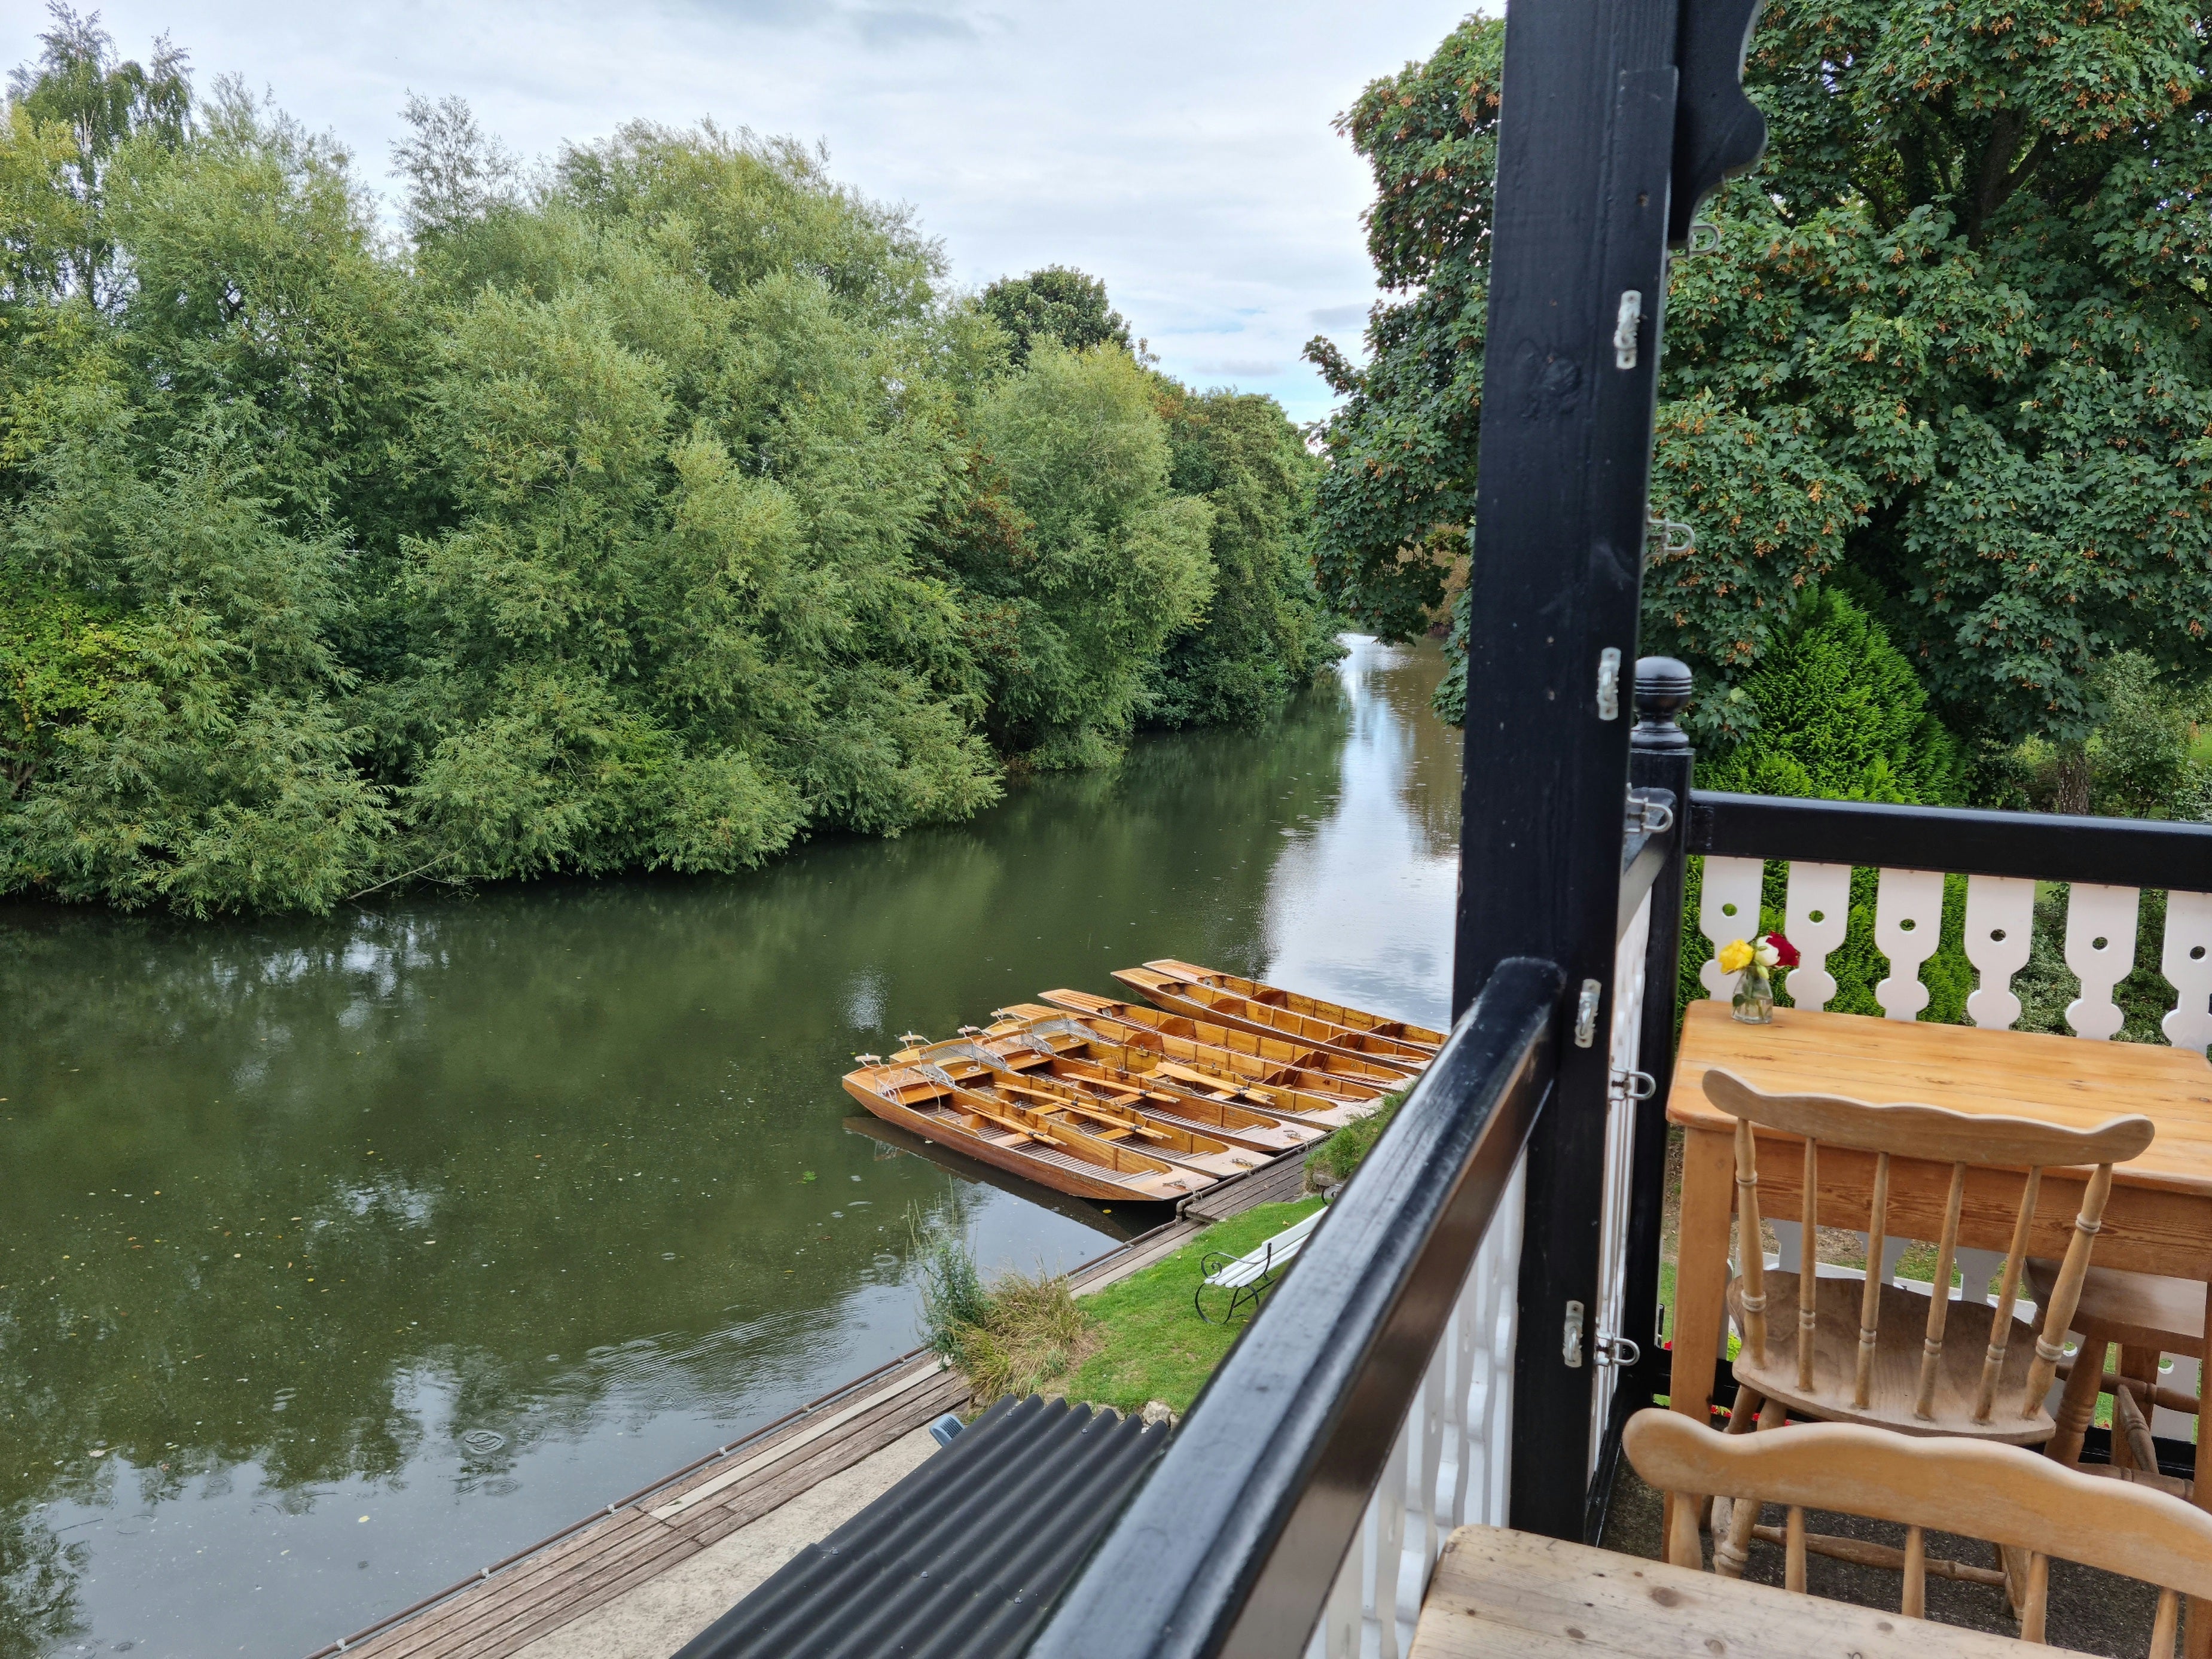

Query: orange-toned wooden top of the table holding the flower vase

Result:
[1665,998,2212,1197]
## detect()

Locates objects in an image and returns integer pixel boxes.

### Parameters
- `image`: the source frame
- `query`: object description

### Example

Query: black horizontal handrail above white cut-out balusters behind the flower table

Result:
[1690,789,2212,892]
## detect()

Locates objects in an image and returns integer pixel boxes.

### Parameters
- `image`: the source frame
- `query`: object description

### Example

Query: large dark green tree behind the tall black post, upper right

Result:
[1312,0,2212,743]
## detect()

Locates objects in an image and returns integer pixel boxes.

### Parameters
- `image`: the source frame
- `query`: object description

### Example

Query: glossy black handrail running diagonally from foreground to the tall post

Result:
[1029,958,1566,1659]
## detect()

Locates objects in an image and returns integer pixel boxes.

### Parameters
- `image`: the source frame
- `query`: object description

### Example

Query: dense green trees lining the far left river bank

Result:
[0,9,1334,914]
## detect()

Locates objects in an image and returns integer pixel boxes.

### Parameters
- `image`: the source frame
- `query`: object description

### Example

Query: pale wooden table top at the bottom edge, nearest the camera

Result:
[1411,1526,2051,1659]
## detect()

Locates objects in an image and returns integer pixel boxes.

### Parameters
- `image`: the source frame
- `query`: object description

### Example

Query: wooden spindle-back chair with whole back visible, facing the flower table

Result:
[1705,1068,2152,1606]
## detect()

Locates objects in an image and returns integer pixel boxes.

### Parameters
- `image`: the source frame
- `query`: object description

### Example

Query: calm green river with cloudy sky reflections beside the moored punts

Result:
[0,639,1460,1659]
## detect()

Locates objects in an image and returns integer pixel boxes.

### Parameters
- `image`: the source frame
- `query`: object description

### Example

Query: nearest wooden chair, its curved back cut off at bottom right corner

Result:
[1621,1411,2212,1659]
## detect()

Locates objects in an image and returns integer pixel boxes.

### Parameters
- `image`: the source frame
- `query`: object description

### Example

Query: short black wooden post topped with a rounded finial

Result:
[1592,657,1694,1424]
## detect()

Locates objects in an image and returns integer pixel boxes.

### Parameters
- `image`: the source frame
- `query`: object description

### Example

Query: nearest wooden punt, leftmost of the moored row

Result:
[845,1064,1215,1203]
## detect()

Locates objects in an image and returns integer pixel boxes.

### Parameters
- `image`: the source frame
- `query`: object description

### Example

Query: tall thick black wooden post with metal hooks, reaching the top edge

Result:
[1453,0,1677,1538]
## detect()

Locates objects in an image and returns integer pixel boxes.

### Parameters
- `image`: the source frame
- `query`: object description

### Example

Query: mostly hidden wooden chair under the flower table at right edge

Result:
[2028,1261,2205,1500]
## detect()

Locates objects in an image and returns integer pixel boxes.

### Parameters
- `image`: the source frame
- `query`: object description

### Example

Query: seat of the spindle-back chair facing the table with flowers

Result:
[1728,1270,2057,1447]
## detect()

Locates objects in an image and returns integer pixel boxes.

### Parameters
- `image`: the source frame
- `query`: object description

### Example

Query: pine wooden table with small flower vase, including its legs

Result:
[1665,1000,2212,1548]
